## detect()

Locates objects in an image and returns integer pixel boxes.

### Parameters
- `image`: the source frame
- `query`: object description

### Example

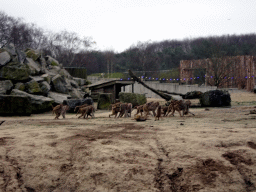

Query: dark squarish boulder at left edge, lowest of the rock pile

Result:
[0,95,32,116]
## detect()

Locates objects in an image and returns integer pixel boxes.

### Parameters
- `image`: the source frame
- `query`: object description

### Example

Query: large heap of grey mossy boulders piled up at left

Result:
[0,44,86,113]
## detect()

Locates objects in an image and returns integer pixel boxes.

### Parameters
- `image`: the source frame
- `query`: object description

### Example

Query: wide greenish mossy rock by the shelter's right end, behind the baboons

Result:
[119,92,147,106]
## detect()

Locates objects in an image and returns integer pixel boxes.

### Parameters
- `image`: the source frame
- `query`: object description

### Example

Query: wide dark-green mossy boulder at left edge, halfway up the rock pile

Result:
[0,62,31,81]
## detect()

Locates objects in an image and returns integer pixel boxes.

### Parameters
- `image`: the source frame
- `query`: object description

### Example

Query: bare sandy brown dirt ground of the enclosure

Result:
[0,92,256,192]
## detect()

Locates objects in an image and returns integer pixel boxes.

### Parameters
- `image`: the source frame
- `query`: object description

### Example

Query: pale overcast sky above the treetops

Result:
[0,0,256,52]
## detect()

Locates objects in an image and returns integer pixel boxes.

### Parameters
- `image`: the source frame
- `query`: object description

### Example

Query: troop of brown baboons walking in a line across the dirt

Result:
[52,100,195,121]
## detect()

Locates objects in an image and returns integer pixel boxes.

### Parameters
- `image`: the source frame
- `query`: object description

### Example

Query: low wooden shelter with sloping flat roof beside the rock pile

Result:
[87,79,134,102]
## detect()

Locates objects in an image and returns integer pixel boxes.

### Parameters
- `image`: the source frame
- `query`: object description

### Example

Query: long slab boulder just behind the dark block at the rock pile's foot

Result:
[11,89,54,113]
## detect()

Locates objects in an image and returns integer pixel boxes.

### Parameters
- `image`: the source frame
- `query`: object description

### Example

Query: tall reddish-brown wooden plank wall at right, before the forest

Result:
[180,55,256,91]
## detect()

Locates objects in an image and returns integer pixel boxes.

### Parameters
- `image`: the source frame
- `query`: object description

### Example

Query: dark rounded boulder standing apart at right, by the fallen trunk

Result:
[200,90,231,107]
